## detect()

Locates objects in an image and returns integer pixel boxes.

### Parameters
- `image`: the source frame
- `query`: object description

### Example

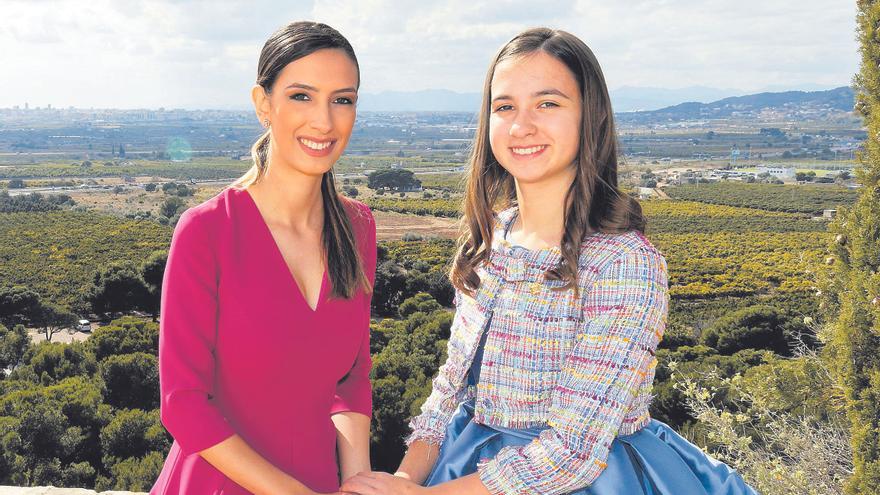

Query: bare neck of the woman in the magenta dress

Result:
[248,153,324,232]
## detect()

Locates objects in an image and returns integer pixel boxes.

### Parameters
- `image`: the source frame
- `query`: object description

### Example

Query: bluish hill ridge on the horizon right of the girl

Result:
[618,86,855,122]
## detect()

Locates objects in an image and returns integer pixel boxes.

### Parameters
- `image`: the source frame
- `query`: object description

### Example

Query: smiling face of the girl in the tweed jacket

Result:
[489,51,583,185]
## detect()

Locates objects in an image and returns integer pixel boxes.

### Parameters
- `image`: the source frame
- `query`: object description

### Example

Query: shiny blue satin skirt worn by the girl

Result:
[425,400,757,495]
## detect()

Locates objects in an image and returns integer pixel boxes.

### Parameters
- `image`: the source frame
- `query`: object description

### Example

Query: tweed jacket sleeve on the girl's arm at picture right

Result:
[478,248,668,495]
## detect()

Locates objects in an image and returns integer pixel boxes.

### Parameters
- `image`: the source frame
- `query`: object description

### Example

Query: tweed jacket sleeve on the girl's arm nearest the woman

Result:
[405,290,467,445]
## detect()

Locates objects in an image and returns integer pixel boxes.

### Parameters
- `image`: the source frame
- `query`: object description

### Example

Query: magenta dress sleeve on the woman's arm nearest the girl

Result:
[330,205,376,416]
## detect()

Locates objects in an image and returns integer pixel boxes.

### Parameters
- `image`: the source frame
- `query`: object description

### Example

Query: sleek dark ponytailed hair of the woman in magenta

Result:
[232,21,371,299]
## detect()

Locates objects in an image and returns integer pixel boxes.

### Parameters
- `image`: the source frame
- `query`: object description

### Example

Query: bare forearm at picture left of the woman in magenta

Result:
[199,435,314,495]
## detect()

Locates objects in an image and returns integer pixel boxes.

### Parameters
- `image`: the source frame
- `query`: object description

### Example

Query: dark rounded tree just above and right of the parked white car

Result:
[86,262,150,313]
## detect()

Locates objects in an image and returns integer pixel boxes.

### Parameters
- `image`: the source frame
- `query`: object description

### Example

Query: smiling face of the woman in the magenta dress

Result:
[254,49,358,175]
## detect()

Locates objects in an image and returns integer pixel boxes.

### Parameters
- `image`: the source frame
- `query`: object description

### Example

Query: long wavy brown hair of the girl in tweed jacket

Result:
[450,28,646,294]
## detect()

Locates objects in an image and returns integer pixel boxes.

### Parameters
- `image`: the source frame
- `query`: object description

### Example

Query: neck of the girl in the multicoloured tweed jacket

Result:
[511,170,574,249]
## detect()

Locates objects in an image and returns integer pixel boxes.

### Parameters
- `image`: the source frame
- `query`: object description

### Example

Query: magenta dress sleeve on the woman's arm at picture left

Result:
[159,210,235,454]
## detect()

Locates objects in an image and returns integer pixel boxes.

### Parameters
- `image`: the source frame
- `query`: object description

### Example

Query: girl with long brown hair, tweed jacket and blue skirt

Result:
[342,28,755,495]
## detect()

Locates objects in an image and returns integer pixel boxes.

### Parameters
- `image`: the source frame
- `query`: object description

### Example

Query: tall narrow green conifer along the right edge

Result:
[822,0,880,495]
